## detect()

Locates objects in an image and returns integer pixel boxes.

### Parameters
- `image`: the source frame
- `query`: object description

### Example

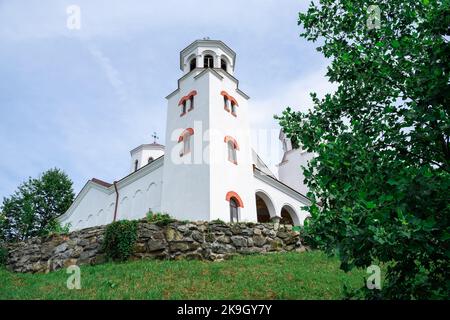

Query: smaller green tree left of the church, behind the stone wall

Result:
[0,169,74,241]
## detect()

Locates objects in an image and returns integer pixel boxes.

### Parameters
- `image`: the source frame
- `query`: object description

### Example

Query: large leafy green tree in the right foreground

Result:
[276,0,450,299]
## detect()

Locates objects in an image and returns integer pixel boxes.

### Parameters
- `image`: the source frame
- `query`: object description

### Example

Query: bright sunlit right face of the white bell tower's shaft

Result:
[209,71,256,222]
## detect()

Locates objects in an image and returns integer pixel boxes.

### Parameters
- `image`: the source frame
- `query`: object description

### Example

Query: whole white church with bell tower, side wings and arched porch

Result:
[59,39,311,230]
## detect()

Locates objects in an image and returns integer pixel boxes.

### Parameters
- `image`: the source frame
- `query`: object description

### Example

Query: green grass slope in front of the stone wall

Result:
[0,251,366,299]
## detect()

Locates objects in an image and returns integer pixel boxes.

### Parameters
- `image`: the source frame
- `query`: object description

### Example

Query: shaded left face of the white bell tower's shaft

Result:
[162,69,210,220]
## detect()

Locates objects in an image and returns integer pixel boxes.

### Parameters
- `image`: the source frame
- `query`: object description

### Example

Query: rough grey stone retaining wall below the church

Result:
[7,220,304,272]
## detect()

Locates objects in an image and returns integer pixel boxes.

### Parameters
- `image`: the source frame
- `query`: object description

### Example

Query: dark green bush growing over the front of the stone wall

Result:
[103,220,137,261]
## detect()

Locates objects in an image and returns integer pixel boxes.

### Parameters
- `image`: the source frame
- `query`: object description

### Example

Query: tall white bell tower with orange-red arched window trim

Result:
[162,39,256,222]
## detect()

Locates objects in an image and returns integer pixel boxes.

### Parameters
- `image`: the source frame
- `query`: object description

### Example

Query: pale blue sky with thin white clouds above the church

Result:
[0,0,332,198]
